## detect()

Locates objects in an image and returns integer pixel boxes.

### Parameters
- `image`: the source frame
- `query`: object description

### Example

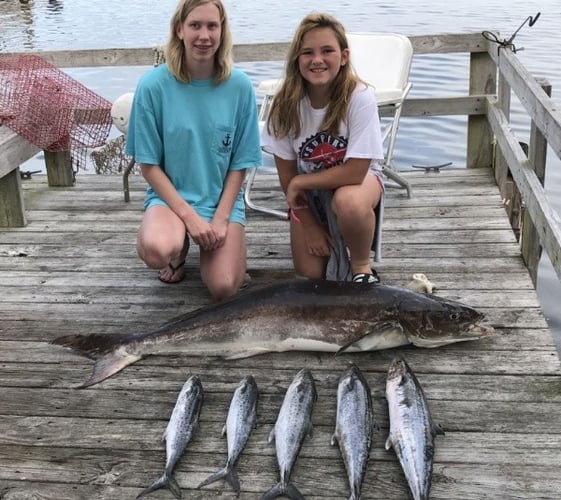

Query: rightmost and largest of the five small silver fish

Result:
[386,358,444,500]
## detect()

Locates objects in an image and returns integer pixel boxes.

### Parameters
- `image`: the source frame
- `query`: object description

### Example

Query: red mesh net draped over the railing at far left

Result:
[0,54,112,171]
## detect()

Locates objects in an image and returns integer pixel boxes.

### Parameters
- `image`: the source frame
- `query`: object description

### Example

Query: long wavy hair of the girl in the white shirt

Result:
[267,12,361,138]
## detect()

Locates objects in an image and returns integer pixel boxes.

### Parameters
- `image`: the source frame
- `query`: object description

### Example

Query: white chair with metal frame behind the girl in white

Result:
[245,32,413,262]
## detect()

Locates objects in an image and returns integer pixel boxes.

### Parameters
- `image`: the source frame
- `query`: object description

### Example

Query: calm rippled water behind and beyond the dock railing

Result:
[0,0,561,345]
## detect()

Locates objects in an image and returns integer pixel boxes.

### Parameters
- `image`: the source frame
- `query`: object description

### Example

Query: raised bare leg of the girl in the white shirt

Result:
[332,175,382,275]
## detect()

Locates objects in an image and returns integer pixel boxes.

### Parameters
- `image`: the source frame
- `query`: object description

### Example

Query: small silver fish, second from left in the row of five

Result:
[197,375,259,496]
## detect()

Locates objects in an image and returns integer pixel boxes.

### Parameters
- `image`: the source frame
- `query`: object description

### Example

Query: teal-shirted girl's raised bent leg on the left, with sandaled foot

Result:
[136,205,189,283]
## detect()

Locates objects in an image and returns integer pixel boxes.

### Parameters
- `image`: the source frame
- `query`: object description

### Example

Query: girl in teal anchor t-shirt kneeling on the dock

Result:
[126,0,261,300]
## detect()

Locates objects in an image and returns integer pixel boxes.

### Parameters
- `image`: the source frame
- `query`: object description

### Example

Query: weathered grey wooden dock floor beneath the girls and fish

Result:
[0,169,561,500]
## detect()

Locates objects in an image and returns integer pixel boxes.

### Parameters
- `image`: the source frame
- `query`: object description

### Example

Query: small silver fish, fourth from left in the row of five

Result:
[331,364,377,500]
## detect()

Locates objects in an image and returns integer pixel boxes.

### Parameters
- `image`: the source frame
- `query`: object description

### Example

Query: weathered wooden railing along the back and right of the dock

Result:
[0,33,561,283]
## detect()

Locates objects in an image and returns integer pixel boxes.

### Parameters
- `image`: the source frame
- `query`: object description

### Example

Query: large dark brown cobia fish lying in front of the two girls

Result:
[53,279,494,387]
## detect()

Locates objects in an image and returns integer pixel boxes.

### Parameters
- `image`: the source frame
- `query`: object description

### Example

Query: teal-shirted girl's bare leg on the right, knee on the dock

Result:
[200,223,247,300]
